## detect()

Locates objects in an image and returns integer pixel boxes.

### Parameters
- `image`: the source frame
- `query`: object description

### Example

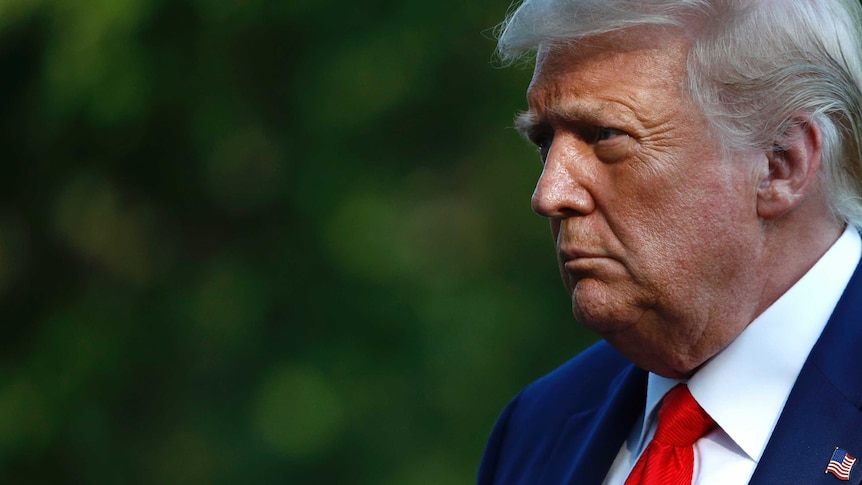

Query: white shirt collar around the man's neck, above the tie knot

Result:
[639,227,862,461]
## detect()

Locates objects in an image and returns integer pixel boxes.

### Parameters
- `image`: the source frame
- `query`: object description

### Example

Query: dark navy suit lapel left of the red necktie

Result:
[540,365,647,485]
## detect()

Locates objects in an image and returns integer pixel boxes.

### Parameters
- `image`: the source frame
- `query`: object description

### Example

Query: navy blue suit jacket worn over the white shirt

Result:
[479,265,862,485]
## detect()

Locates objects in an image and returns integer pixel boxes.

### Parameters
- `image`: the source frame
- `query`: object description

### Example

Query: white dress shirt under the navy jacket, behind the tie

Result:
[604,227,862,485]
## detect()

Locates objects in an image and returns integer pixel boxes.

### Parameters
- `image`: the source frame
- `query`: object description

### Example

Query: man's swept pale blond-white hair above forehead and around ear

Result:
[497,0,862,227]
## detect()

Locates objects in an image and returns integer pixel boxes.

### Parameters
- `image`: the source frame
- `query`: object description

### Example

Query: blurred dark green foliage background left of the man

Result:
[0,0,594,485]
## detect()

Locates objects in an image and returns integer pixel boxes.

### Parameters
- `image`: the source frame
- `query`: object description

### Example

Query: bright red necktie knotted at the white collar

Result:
[625,384,715,485]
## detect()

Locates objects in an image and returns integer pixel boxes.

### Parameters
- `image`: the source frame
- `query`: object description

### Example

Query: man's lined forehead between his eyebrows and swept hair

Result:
[527,31,689,115]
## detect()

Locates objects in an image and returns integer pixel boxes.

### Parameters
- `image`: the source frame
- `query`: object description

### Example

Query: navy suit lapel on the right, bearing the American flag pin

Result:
[749,265,862,485]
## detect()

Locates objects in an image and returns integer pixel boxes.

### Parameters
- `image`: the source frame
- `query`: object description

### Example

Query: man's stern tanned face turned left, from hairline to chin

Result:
[518,31,763,376]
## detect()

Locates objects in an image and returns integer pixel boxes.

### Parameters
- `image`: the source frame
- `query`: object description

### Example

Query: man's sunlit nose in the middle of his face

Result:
[532,140,595,218]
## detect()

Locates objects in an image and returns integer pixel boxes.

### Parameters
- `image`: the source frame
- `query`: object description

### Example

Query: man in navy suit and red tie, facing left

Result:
[479,0,862,485]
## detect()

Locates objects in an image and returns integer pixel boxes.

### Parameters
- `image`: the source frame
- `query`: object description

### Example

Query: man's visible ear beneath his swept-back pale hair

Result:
[757,117,822,219]
